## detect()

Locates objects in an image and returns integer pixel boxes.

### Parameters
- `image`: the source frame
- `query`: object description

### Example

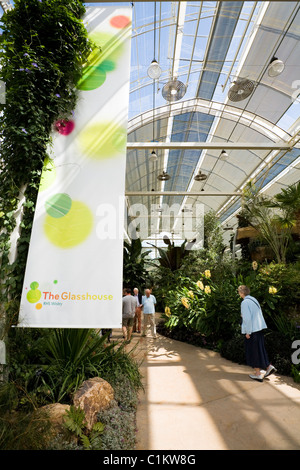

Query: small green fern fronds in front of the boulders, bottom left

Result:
[64,405,104,450]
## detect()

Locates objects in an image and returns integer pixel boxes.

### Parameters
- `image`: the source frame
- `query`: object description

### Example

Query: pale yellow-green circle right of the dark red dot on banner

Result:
[79,122,127,160]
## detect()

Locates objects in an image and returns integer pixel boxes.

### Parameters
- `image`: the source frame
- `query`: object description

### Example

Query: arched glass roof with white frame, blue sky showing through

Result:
[0,1,300,246]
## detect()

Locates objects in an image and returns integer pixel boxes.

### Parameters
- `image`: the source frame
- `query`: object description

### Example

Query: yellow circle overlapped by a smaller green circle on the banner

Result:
[44,201,93,248]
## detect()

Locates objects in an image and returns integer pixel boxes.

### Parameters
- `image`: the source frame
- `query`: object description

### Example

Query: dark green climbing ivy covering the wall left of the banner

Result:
[0,0,92,330]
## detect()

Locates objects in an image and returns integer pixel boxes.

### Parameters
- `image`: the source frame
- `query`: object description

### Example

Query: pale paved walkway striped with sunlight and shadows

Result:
[112,326,300,450]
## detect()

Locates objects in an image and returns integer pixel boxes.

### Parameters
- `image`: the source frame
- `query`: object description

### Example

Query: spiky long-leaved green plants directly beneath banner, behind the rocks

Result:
[0,328,142,412]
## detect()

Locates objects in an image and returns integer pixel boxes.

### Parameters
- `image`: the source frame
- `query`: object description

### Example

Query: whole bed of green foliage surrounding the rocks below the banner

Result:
[0,328,142,450]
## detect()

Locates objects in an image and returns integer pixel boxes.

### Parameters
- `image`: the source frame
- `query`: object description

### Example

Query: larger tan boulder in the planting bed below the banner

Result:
[73,377,114,430]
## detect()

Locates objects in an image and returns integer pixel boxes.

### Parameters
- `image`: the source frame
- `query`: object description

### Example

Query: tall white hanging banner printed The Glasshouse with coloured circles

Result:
[18,7,131,328]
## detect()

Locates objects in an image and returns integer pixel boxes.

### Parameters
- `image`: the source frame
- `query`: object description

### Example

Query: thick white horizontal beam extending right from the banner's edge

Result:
[127,142,293,150]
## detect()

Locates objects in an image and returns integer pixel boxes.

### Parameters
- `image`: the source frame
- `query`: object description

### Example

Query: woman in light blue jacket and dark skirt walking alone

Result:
[238,286,276,382]
